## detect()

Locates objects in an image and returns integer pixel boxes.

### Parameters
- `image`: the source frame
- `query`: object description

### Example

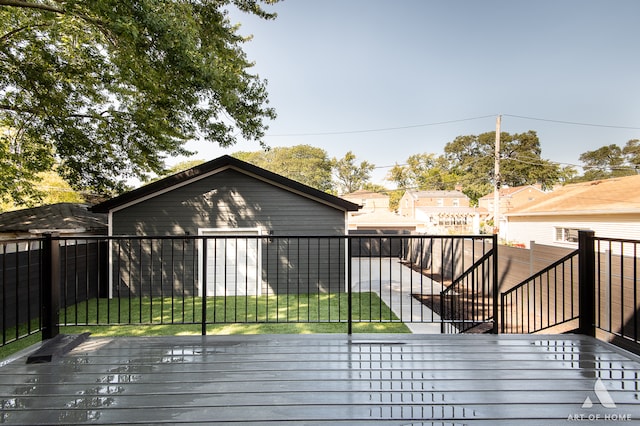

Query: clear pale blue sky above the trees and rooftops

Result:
[179,0,640,183]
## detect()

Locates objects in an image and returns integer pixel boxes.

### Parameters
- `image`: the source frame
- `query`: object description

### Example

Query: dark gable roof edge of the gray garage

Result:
[91,155,360,213]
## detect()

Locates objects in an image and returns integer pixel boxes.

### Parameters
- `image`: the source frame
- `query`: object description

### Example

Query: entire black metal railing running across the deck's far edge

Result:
[0,231,640,350]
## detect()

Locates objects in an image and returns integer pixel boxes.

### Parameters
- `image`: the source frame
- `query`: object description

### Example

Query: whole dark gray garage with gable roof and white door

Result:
[92,156,360,296]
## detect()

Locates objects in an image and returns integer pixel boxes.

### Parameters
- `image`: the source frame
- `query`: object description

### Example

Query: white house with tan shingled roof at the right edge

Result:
[506,175,640,248]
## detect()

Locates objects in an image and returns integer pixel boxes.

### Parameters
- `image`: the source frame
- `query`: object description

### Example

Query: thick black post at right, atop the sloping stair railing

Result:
[578,231,596,337]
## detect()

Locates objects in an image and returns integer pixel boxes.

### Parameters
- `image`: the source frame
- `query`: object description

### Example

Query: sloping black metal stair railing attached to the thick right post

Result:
[500,250,579,334]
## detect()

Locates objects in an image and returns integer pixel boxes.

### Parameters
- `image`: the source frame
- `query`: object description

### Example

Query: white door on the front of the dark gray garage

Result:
[198,228,262,296]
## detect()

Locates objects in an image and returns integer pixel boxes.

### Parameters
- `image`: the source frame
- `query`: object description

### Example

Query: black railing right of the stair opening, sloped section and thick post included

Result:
[501,231,640,353]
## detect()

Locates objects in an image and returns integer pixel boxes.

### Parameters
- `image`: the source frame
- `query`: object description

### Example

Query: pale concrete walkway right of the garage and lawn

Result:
[351,257,442,334]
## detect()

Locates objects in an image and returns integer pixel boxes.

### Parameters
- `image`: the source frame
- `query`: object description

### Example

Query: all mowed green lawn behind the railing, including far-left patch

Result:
[0,292,410,359]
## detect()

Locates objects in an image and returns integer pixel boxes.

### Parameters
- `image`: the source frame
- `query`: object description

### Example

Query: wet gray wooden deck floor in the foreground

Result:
[0,335,640,425]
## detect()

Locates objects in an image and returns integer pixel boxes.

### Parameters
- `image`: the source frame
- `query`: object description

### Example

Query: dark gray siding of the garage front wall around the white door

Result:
[112,169,345,296]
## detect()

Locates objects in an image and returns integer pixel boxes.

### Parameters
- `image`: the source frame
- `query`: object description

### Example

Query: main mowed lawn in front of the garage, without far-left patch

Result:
[60,292,408,335]
